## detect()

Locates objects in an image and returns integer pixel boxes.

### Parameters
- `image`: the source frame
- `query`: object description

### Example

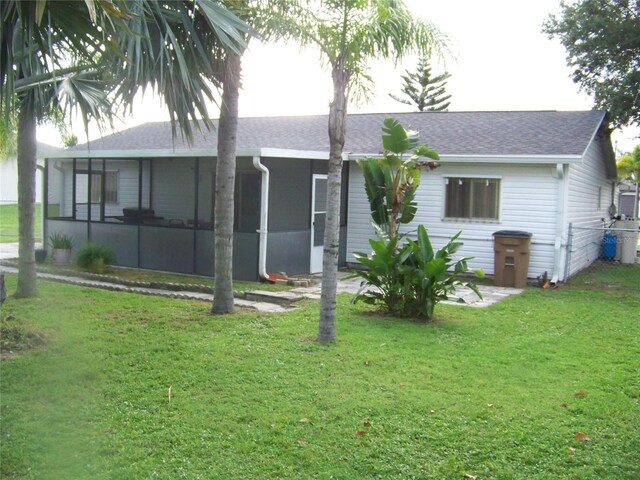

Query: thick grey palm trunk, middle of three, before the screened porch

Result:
[211,52,242,314]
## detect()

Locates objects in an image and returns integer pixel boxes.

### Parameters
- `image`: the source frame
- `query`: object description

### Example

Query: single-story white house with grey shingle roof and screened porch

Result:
[44,110,616,280]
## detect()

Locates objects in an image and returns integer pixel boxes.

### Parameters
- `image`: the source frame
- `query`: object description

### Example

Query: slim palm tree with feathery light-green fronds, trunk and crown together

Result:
[276,0,443,342]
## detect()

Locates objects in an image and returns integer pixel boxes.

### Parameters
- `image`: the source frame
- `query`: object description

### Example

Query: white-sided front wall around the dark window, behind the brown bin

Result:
[346,162,558,278]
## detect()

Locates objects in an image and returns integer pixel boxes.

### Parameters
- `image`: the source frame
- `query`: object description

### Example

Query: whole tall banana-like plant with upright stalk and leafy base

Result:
[350,119,483,320]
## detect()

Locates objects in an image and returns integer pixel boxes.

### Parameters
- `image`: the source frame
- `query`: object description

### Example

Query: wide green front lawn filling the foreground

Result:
[0,270,640,479]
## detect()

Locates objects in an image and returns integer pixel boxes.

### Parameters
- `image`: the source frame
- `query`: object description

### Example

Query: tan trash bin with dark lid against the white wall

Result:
[493,230,531,288]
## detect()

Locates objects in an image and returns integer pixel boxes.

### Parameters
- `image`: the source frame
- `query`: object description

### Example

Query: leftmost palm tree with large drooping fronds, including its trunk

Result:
[0,0,247,297]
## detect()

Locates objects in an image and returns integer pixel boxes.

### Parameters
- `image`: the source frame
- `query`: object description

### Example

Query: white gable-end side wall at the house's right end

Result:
[567,140,614,276]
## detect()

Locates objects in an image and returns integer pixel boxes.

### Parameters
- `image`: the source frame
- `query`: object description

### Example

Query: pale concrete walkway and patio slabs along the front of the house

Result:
[0,243,524,313]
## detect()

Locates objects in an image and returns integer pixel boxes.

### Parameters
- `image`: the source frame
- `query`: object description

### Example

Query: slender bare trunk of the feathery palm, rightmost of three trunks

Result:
[318,64,348,343]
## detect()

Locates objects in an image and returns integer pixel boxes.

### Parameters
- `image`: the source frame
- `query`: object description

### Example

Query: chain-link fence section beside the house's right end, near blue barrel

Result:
[565,221,640,289]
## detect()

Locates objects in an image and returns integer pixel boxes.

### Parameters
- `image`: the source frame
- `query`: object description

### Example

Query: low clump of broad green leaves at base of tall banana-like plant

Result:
[353,225,483,320]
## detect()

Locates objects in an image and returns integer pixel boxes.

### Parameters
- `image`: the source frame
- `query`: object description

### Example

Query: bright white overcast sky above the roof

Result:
[38,0,640,152]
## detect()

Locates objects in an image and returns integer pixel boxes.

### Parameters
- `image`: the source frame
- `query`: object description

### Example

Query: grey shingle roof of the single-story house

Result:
[71,110,606,156]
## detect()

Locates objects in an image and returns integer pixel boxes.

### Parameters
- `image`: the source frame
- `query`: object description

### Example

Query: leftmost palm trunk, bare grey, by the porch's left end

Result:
[16,107,38,298]
